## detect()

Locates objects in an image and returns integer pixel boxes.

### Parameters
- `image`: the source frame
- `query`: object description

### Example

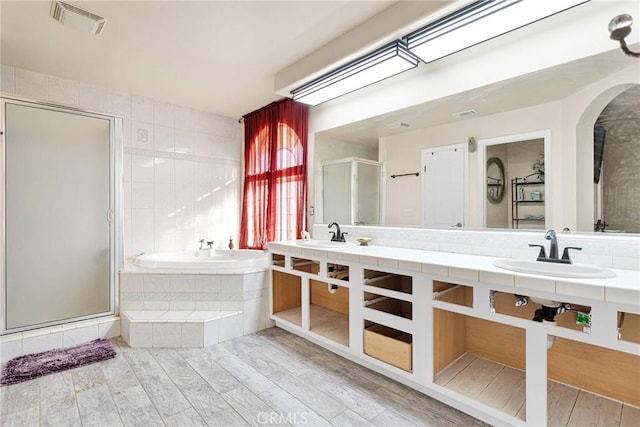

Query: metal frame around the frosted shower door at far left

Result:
[0,94,124,335]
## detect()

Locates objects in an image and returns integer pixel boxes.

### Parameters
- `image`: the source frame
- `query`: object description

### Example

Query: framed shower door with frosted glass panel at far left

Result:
[0,96,122,334]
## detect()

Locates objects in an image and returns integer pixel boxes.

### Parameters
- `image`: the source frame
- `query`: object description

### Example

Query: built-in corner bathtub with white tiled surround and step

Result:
[120,249,271,347]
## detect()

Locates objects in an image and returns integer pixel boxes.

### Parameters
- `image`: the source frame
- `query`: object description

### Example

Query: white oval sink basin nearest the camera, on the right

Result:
[493,259,616,279]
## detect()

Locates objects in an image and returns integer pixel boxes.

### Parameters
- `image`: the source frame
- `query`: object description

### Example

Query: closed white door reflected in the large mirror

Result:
[422,145,468,227]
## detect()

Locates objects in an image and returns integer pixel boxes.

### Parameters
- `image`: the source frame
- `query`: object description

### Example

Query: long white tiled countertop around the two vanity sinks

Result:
[269,240,640,306]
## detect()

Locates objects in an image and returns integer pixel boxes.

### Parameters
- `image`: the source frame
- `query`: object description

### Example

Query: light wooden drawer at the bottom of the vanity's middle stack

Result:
[364,325,413,372]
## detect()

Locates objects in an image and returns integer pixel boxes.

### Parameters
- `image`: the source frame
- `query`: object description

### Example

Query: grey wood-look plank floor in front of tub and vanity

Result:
[0,328,484,427]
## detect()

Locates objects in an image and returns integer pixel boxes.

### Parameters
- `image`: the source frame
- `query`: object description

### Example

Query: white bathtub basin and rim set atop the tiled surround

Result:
[133,249,269,271]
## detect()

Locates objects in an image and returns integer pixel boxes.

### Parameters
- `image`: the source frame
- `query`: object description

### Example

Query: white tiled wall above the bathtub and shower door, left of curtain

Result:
[1,65,241,257]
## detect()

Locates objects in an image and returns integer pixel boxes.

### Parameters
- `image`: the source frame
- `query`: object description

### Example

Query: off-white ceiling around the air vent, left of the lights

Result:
[0,0,396,117]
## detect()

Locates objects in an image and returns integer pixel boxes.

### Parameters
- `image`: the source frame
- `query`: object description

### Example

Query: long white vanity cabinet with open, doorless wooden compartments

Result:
[270,242,640,426]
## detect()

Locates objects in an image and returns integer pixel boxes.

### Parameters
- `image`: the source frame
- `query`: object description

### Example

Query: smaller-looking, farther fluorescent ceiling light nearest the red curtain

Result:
[291,40,418,105]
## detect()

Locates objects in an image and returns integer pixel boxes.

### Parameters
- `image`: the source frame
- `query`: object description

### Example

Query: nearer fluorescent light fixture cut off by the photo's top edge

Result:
[405,0,589,62]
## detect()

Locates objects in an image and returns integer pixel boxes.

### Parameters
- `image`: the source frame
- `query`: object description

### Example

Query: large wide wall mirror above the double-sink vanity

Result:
[310,49,640,233]
